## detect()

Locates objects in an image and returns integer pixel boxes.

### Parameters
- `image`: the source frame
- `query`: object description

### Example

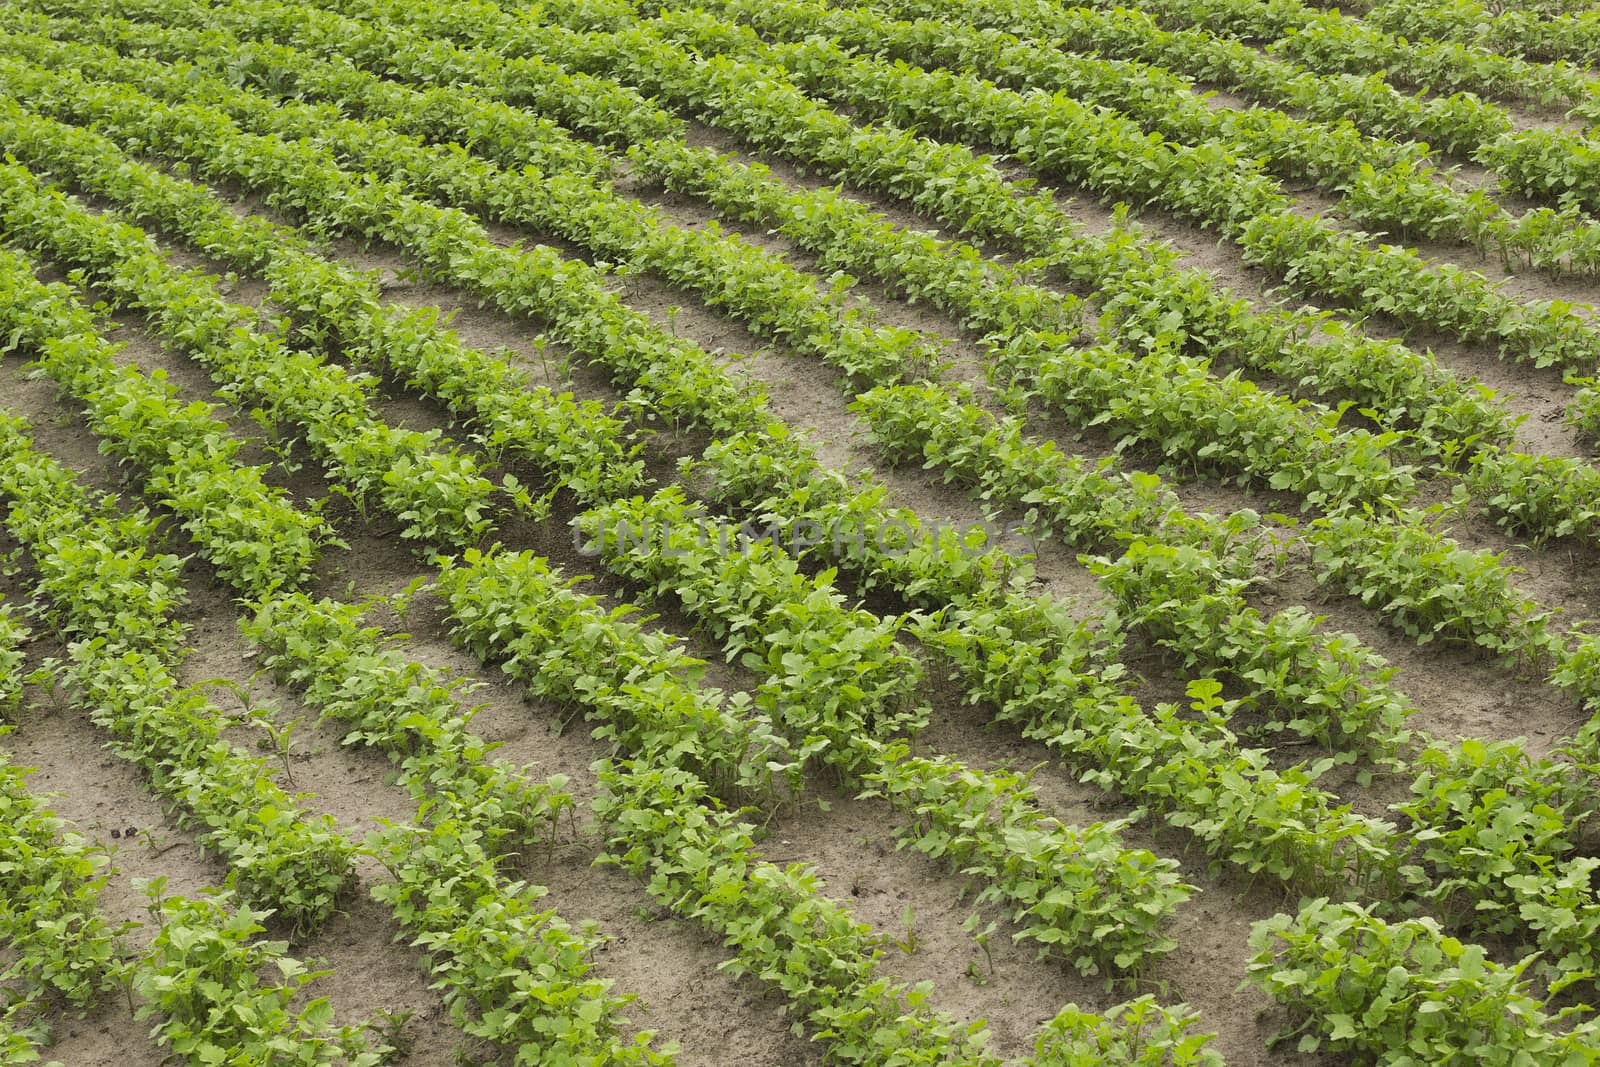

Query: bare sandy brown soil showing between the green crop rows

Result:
[9,18,1600,1067]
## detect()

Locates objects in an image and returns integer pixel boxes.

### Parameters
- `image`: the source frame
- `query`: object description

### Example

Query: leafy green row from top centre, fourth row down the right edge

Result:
[678,0,1600,275]
